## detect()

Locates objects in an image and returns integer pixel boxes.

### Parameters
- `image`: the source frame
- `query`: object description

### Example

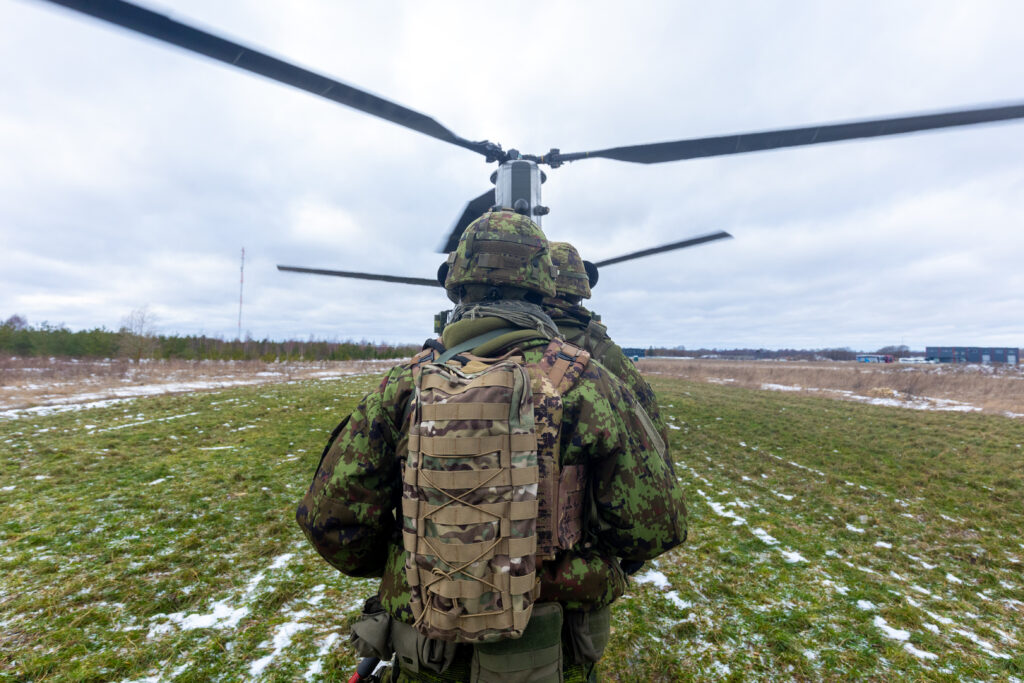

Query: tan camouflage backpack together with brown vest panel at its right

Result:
[401,340,589,643]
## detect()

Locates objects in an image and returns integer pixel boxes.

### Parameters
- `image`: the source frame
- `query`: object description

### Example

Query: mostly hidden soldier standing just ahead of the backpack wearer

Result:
[544,242,672,456]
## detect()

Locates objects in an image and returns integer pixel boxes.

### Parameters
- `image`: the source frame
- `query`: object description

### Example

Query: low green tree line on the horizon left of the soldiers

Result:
[0,315,420,362]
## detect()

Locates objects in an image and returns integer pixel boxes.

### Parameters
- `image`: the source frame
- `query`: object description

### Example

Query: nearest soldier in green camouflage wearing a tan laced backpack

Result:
[297,211,686,682]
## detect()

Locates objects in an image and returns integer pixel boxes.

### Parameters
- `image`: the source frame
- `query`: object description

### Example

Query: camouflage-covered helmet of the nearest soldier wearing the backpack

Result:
[437,210,558,303]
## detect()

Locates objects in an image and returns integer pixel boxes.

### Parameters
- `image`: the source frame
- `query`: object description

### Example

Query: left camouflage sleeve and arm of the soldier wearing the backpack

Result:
[296,368,412,577]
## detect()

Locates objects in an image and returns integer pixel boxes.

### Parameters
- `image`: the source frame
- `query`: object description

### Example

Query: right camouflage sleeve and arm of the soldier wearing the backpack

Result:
[563,364,686,561]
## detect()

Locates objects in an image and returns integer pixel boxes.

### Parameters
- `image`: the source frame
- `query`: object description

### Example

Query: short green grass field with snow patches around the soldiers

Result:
[0,377,1024,681]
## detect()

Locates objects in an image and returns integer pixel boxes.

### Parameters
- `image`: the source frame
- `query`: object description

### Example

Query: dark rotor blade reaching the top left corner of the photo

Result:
[45,0,501,161]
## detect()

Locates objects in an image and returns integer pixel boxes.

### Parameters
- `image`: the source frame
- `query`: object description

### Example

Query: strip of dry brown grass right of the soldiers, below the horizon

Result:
[639,358,1024,416]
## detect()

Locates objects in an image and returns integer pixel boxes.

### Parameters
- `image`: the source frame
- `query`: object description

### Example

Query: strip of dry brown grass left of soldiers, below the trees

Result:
[0,356,396,410]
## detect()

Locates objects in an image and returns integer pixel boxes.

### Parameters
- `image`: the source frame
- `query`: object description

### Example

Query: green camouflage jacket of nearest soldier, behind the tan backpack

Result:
[296,321,686,623]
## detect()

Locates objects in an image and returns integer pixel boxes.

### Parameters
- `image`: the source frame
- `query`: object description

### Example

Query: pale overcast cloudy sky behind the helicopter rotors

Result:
[0,0,1024,349]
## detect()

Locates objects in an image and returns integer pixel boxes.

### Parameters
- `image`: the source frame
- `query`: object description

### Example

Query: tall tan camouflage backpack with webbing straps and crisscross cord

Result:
[401,356,539,643]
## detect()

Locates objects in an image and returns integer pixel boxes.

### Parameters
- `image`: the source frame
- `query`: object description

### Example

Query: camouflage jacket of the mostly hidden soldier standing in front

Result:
[544,297,672,454]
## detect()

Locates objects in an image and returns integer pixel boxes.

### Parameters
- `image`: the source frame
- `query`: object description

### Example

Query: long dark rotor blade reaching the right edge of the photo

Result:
[543,103,1024,165]
